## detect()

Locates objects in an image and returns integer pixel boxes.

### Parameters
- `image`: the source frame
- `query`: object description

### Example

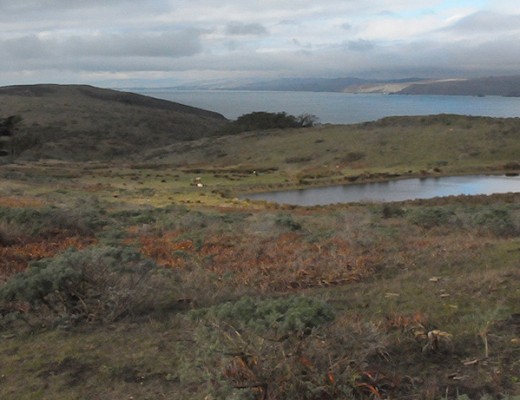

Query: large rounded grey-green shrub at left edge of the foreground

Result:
[0,247,156,323]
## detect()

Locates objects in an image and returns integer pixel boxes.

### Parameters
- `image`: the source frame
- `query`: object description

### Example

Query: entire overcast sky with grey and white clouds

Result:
[0,0,520,86]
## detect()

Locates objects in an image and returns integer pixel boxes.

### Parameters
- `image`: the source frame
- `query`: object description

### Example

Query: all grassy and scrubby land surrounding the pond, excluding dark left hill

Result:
[0,115,520,400]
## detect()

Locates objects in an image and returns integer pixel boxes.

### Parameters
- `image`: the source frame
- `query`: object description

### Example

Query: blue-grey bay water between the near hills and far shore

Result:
[132,89,520,124]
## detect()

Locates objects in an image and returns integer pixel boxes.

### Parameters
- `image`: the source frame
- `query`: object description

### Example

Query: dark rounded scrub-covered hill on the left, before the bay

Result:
[0,84,226,161]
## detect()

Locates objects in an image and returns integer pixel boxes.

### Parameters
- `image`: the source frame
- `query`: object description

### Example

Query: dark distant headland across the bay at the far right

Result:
[397,75,520,97]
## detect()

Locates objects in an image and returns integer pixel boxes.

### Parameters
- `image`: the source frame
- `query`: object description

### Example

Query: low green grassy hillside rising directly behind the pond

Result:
[146,115,520,184]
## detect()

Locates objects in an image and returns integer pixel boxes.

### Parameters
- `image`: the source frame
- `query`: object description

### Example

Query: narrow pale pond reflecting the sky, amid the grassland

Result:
[244,175,520,206]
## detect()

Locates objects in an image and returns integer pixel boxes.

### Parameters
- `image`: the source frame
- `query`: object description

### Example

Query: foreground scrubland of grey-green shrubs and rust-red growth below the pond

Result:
[0,184,520,399]
